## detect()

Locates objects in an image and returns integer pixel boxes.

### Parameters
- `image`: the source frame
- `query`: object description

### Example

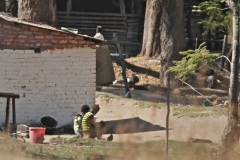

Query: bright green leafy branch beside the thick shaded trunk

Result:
[168,43,219,82]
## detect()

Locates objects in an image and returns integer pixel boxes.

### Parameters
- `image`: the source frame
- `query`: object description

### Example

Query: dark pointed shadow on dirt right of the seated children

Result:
[104,117,166,134]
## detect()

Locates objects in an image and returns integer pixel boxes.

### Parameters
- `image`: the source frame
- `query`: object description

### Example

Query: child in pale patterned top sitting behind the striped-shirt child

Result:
[73,105,90,138]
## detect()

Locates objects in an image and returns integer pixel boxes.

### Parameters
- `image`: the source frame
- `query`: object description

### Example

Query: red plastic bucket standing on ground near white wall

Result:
[29,127,46,143]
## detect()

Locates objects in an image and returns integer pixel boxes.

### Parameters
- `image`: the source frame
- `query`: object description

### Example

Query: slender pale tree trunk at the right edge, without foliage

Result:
[222,1,239,156]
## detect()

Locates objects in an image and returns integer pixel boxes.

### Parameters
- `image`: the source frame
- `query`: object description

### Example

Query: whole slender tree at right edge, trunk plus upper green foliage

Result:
[196,0,240,155]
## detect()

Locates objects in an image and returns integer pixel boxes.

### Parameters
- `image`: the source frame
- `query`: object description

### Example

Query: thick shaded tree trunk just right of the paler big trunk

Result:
[160,0,186,86]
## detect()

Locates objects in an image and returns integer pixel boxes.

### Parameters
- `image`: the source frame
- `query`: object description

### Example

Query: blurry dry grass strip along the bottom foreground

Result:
[0,135,239,160]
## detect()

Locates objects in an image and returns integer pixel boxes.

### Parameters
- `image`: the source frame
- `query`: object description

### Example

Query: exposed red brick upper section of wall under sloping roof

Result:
[0,19,95,50]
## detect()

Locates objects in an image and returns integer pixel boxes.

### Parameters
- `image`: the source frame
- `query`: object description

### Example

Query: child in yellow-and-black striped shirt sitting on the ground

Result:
[82,105,113,141]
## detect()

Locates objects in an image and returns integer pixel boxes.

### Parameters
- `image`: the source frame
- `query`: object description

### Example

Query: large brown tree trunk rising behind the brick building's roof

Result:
[18,0,57,27]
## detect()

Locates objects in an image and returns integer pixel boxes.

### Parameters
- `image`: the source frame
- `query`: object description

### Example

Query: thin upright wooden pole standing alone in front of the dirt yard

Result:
[165,73,170,154]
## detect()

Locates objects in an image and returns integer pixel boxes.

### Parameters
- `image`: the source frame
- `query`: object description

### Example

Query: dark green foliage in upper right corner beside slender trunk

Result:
[198,0,232,34]
